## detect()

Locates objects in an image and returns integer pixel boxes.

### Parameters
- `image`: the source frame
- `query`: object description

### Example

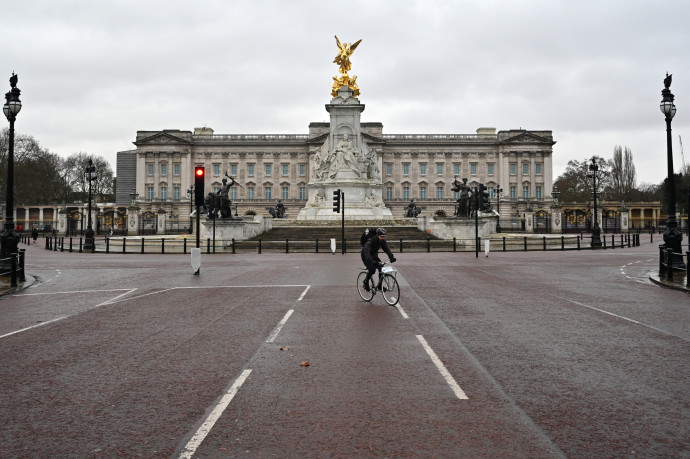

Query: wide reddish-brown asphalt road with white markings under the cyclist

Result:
[0,244,690,457]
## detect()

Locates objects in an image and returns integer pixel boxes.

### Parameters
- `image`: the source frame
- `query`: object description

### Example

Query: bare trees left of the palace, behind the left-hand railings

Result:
[0,128,113,206]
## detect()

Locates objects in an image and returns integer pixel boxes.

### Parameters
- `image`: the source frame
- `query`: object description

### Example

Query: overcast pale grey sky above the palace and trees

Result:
[5,0,690,187]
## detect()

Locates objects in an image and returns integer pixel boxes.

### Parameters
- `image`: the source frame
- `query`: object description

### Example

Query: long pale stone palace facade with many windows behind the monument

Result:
[116,122,555,227]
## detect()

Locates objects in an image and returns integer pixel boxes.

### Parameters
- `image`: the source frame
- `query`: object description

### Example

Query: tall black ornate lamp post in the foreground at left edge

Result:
[0,72,22,258]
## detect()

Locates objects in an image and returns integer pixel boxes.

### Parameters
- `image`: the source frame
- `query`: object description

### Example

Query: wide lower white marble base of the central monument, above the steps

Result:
[297,180,394,222]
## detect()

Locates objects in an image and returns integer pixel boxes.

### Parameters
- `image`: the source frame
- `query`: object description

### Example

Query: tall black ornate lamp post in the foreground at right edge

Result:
[659,73,685,268]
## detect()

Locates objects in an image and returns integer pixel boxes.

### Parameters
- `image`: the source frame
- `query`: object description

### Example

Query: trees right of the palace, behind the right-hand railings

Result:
[554,145,690,216]
